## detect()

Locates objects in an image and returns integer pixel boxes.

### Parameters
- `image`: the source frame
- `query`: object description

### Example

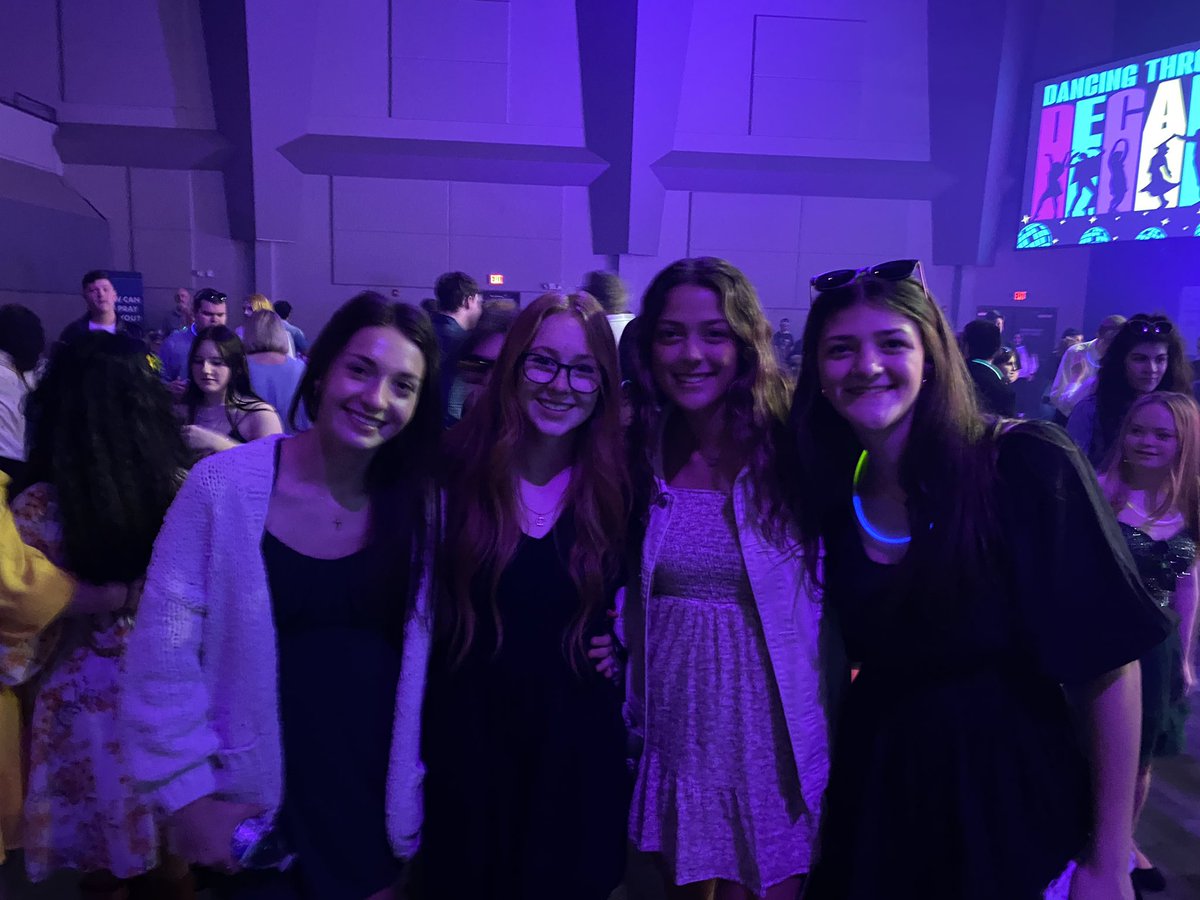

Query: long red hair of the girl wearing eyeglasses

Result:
[438,293,629,671]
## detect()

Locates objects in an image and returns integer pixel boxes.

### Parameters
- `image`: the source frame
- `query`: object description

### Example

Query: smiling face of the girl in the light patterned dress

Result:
[650,284,738,412]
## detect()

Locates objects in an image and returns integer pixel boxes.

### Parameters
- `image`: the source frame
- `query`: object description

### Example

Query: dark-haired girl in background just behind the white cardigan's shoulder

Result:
[180,325,283,457]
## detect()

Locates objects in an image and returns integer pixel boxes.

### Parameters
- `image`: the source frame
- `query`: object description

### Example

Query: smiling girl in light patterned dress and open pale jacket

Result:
[624,258,828,900]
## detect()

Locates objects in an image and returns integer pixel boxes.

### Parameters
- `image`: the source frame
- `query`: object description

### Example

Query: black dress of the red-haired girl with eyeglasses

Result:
[418,522,631,900]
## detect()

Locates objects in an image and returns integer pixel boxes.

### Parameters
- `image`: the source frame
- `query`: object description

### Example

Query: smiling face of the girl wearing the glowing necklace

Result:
[817,300,925,439]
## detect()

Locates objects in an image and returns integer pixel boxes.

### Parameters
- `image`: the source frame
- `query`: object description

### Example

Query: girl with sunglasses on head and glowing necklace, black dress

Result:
[788,260,1169,900]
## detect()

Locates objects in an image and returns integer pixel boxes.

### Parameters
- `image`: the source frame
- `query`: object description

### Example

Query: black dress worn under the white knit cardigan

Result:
[263,532,403,900]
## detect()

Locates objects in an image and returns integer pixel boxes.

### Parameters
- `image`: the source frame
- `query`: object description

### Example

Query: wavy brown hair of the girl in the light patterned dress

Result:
[626,257,791,540]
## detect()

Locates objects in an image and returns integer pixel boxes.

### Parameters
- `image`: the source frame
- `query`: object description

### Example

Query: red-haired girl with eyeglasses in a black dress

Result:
[419,294,629,900]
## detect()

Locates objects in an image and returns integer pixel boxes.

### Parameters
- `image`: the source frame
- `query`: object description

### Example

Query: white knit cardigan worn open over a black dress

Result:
[121,438,432,858]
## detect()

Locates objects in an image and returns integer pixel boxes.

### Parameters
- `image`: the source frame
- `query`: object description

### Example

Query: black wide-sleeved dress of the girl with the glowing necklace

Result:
[805,424,1169,900]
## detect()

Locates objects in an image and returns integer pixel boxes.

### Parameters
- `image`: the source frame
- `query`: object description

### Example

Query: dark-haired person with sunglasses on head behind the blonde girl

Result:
[1067,313,1192,469]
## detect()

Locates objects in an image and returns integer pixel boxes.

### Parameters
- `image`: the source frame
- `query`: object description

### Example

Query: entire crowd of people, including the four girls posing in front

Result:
[0,258,1200,900]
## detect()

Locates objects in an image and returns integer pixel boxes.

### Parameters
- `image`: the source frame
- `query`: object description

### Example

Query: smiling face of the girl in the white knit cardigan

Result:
[316,325,425,450]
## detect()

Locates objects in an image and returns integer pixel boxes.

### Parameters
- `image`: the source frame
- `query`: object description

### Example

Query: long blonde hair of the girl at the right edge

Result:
[1100,391,1200,534]
